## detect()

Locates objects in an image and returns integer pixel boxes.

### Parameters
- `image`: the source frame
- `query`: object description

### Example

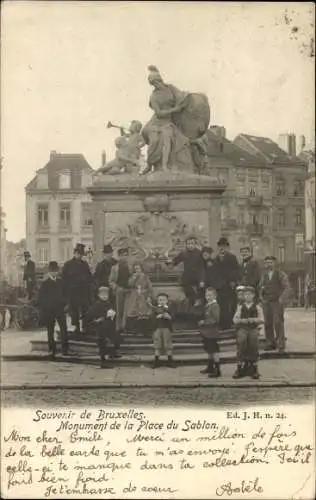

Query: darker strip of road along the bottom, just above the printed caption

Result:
[2,387,315,408]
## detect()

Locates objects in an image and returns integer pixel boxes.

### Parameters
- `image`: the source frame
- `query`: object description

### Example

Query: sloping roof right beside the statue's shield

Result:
[203,130,266,167]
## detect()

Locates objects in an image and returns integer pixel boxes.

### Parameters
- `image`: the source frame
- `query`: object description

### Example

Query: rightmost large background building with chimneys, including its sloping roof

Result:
[234,134,307,296]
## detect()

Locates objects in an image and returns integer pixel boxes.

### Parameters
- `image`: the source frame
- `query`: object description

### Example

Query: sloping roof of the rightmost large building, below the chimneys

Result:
[233,134,302,164]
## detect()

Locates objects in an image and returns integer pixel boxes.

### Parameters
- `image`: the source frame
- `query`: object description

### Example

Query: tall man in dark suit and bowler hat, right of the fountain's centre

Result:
[214,237,239,330]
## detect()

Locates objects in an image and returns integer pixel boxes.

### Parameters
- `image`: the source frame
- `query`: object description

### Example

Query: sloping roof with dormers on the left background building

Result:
[25,152,94,191]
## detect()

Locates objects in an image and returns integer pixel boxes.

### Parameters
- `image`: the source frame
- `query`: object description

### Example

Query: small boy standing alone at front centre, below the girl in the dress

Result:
[153,293,174,368]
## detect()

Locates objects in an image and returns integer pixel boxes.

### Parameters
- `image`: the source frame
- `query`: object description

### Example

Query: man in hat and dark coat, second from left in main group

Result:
[62,243,93,333]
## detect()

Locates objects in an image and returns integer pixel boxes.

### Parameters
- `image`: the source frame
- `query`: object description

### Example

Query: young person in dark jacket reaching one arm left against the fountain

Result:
[170,236,204,307]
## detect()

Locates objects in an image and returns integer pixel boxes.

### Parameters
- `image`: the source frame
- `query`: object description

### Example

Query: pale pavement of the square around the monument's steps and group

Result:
[1,310,315,390]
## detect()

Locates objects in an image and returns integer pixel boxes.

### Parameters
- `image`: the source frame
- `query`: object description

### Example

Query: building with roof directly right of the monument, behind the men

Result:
[206,127,273,260]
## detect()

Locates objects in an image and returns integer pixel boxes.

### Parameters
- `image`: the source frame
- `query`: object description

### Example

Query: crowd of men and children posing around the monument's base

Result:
[25,236,291,378]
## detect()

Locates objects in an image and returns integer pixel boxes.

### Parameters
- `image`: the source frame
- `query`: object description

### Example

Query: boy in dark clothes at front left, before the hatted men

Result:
[87,286,117,368]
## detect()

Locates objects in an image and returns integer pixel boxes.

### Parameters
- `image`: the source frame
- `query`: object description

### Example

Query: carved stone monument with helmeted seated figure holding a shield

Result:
[89,66,225,308]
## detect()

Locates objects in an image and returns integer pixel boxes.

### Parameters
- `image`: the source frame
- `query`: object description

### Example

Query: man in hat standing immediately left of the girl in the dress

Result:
[109,248,131,333]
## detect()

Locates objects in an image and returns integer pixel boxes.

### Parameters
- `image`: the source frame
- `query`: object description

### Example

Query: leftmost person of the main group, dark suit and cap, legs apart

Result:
[38,261,68,358]
